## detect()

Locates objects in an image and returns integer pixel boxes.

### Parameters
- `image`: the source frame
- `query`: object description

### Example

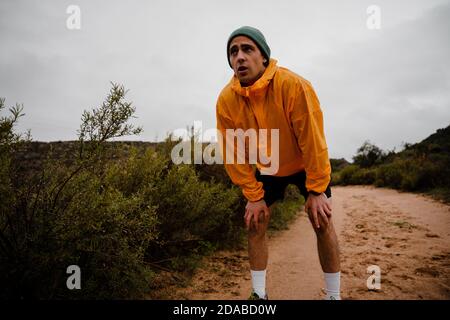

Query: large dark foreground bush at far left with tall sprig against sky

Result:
[0,84,163,299]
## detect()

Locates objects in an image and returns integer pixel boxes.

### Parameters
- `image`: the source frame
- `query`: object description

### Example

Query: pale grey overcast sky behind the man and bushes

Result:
[0,0,450,160]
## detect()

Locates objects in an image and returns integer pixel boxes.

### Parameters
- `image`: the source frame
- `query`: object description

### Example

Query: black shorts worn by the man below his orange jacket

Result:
[255,170,331,207]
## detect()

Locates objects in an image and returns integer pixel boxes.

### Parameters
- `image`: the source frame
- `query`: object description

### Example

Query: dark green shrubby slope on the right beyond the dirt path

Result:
[333,126,450,202]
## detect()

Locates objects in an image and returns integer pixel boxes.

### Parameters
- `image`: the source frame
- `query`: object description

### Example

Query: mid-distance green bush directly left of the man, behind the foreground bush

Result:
[108,149,243,269]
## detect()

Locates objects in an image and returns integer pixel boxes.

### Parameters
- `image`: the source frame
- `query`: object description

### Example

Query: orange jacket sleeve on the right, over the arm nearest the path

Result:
[290,82,331,192]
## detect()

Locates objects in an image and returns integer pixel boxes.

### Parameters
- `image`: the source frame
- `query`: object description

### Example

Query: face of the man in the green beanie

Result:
[228,36,266,87]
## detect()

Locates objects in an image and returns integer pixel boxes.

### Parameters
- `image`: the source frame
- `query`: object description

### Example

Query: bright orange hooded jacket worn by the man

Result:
[216,59,331,201]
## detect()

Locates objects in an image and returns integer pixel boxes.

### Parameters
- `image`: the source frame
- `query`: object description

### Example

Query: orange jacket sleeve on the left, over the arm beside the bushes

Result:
[216,98,264,201]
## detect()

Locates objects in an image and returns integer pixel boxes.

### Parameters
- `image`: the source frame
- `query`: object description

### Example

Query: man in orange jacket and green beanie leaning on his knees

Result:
[216,26,340,300]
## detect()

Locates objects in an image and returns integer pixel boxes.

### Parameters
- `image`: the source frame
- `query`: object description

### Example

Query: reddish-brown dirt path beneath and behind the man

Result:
[169,186,450,300]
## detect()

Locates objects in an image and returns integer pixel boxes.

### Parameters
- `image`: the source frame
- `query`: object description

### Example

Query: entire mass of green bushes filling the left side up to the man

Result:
[0,84,248,299]
